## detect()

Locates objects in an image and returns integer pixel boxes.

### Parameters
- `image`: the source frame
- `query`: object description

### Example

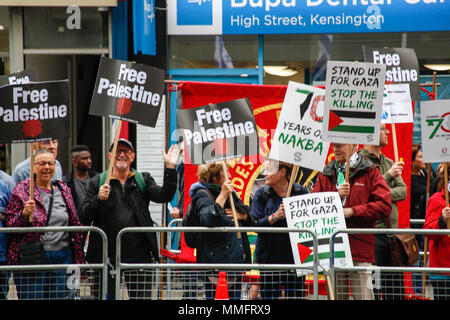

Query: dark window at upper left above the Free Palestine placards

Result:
[23,7,108,49]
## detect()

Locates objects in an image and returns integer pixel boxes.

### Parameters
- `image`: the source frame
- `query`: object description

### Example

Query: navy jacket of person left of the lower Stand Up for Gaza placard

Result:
[251,183,308,264]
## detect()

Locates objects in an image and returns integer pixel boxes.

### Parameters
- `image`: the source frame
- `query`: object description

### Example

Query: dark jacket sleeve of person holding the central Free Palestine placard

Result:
[192,191,225,227]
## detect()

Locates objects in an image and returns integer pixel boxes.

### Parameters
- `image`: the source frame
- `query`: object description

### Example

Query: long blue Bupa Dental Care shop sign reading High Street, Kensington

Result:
[169,0,450,34]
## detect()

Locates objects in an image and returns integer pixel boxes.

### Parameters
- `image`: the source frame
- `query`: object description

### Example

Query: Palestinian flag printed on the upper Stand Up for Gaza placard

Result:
[328,110,376,133]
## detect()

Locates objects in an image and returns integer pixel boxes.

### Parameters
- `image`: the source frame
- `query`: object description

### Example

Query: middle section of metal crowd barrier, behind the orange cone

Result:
[115,227,319,300]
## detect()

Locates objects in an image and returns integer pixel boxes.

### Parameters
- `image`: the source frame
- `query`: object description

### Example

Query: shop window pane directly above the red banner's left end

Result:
[170,35,258,69]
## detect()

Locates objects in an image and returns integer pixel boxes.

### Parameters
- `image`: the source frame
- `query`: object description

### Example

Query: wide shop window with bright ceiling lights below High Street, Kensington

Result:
[264,32,450,84]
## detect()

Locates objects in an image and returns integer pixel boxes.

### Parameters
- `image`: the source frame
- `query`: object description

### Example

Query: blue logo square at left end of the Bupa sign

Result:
[177,0,212,26]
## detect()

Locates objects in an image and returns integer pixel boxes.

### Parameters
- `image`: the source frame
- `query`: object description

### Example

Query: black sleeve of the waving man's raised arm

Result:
[142,168,177,203]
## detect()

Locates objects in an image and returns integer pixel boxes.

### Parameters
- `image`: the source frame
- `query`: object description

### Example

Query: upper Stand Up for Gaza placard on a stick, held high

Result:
[323,61,386,181]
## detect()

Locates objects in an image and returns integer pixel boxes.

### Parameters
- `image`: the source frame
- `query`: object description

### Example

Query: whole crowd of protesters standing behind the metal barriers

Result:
[0,125,450,300]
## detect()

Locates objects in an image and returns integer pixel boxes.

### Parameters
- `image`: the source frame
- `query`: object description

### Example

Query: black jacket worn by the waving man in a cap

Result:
[80,169,177,265]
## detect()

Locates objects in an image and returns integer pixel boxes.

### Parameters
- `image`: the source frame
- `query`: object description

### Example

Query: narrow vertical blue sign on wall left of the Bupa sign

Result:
[133,0,156,56]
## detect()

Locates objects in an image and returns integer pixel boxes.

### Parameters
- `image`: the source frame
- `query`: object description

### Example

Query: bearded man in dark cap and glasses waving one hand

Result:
[80,139,179,300]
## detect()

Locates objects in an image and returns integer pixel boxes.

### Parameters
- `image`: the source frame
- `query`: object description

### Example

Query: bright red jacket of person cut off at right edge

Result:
[423,189,450,268]
